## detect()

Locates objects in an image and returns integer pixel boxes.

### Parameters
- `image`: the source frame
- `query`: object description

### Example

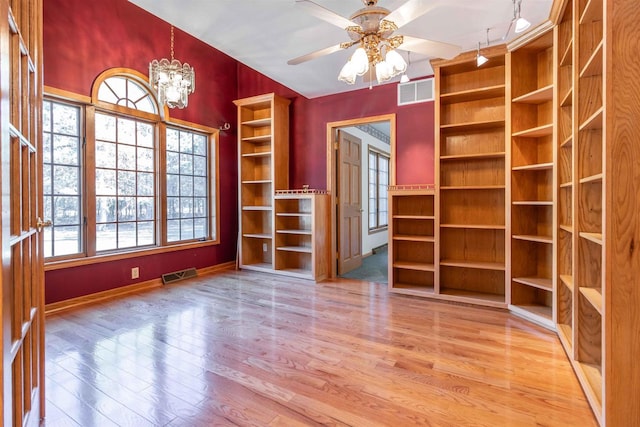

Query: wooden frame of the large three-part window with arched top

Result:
[44,68,220,271]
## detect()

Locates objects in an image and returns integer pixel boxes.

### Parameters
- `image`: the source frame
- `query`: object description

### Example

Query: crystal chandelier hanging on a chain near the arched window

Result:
[149,25,196,108]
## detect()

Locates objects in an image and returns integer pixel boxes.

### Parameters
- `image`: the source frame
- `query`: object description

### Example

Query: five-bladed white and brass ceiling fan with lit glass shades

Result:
[287,0,462,84]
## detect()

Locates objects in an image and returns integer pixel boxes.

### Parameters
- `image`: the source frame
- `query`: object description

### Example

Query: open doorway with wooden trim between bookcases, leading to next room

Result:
[327,114,396,282]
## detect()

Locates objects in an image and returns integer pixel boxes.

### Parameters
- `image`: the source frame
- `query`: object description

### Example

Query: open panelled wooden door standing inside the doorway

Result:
[337,131,362,274]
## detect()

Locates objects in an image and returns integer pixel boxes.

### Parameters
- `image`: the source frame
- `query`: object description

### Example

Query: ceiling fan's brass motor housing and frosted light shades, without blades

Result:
[338,7,407,84]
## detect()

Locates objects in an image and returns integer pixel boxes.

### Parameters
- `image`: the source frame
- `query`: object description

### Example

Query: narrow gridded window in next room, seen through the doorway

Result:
[369,150,389,231]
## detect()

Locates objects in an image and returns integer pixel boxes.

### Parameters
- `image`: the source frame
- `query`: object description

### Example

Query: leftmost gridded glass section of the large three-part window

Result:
[42,100,83,257]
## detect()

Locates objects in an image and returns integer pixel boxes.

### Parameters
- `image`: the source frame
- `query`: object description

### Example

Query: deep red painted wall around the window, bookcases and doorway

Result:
[44,0,433,303]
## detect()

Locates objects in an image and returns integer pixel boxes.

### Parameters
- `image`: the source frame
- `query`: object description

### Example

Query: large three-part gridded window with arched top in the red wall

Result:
[43,75,217,260]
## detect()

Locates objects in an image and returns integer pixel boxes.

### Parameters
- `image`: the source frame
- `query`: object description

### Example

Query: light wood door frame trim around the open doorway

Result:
[326,113,396,278]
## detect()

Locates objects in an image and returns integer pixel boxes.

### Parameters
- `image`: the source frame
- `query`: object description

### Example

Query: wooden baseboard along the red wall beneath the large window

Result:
[45,261,235,314]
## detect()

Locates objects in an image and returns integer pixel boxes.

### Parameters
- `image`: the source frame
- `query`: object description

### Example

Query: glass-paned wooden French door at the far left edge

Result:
[0,0,44,426]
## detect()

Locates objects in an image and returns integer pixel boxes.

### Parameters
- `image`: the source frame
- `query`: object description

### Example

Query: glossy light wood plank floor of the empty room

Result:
[46,271,596,427]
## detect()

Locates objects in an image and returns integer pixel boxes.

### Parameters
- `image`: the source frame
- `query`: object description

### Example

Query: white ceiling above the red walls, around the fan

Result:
[129,0,552,98]
